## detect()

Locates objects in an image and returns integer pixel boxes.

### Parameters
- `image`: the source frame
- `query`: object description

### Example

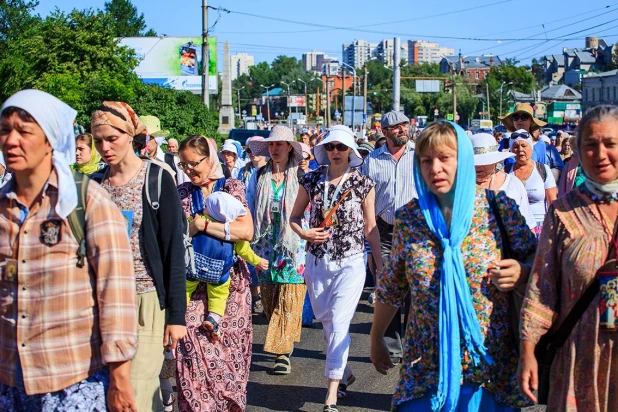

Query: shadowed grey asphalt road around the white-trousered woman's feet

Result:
[247,289,398,411]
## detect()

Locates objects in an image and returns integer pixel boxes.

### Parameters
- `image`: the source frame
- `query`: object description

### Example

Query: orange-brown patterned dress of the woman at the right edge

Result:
[521,188,618,412]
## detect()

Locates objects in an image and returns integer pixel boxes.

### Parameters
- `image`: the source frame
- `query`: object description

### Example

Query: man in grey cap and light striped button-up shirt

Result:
[361,111,417,362]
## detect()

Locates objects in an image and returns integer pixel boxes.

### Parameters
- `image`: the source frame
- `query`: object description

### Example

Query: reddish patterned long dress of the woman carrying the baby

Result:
[176,179,253,412]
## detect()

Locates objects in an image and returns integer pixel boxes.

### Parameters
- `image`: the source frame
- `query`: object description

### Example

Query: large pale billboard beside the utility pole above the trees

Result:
[120,37,218,93]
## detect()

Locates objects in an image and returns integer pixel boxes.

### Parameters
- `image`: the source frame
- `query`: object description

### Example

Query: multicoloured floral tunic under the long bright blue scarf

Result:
[376,187,537,406]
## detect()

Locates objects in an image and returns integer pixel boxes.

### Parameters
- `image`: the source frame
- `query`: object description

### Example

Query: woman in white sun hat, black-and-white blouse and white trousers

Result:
[290,125,382,412]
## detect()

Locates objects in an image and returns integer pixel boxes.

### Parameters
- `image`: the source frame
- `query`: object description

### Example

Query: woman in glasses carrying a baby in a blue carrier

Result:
[176,135,253,411]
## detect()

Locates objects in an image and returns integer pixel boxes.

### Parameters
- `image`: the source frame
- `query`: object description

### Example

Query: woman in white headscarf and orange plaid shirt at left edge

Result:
[0,90,137,411]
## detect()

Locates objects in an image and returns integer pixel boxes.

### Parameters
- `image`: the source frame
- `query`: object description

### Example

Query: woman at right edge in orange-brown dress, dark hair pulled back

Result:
[519,105,618,411]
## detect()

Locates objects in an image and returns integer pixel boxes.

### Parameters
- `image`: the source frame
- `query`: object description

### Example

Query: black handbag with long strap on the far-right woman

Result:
[534,217,618,405]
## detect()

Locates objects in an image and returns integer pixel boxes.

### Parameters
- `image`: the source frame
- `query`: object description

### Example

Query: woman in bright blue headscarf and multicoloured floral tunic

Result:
[371,122,536,411]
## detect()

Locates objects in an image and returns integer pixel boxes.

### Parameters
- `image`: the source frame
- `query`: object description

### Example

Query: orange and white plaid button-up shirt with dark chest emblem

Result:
[0,172,137,395]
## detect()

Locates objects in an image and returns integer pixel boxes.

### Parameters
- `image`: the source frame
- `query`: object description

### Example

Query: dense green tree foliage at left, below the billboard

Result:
[0,3,219,139]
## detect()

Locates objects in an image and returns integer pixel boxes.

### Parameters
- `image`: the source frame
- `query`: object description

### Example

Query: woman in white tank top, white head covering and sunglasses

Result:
[507,129,557,237]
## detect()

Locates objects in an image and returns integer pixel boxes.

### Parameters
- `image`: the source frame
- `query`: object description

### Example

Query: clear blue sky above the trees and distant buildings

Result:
[37,0,618,69]
